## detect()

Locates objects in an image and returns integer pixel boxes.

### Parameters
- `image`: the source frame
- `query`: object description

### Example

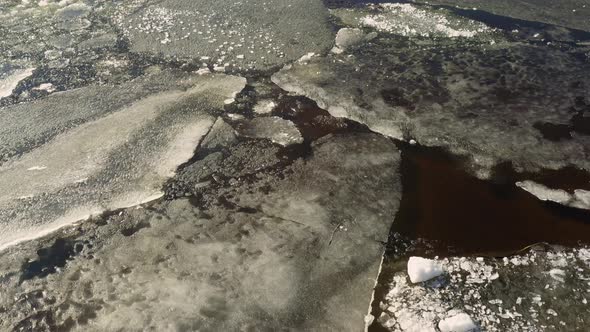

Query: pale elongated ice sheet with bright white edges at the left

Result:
[0,71,245,247]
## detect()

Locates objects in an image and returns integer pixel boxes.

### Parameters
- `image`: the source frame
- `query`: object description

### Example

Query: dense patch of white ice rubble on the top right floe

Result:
[361,3,492,38]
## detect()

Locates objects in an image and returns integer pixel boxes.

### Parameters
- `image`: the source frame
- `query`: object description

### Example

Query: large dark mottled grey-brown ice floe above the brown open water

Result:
[272,7,590,178]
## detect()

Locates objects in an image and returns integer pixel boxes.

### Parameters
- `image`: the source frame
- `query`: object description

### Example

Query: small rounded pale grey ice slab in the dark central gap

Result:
[237,116,303,146]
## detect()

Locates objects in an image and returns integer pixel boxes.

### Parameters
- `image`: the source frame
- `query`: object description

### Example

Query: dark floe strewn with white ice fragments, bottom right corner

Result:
[377,248,590,332]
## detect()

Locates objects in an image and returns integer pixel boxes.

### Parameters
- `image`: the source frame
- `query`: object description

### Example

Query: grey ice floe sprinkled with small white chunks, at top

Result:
[115,0,333,71]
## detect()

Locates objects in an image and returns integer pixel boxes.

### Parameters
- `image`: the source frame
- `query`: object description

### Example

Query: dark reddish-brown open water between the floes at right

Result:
[392,145,590,256]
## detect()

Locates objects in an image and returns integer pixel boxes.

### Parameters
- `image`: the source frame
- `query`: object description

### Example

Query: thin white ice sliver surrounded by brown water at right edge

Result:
[516,180,590,210]
